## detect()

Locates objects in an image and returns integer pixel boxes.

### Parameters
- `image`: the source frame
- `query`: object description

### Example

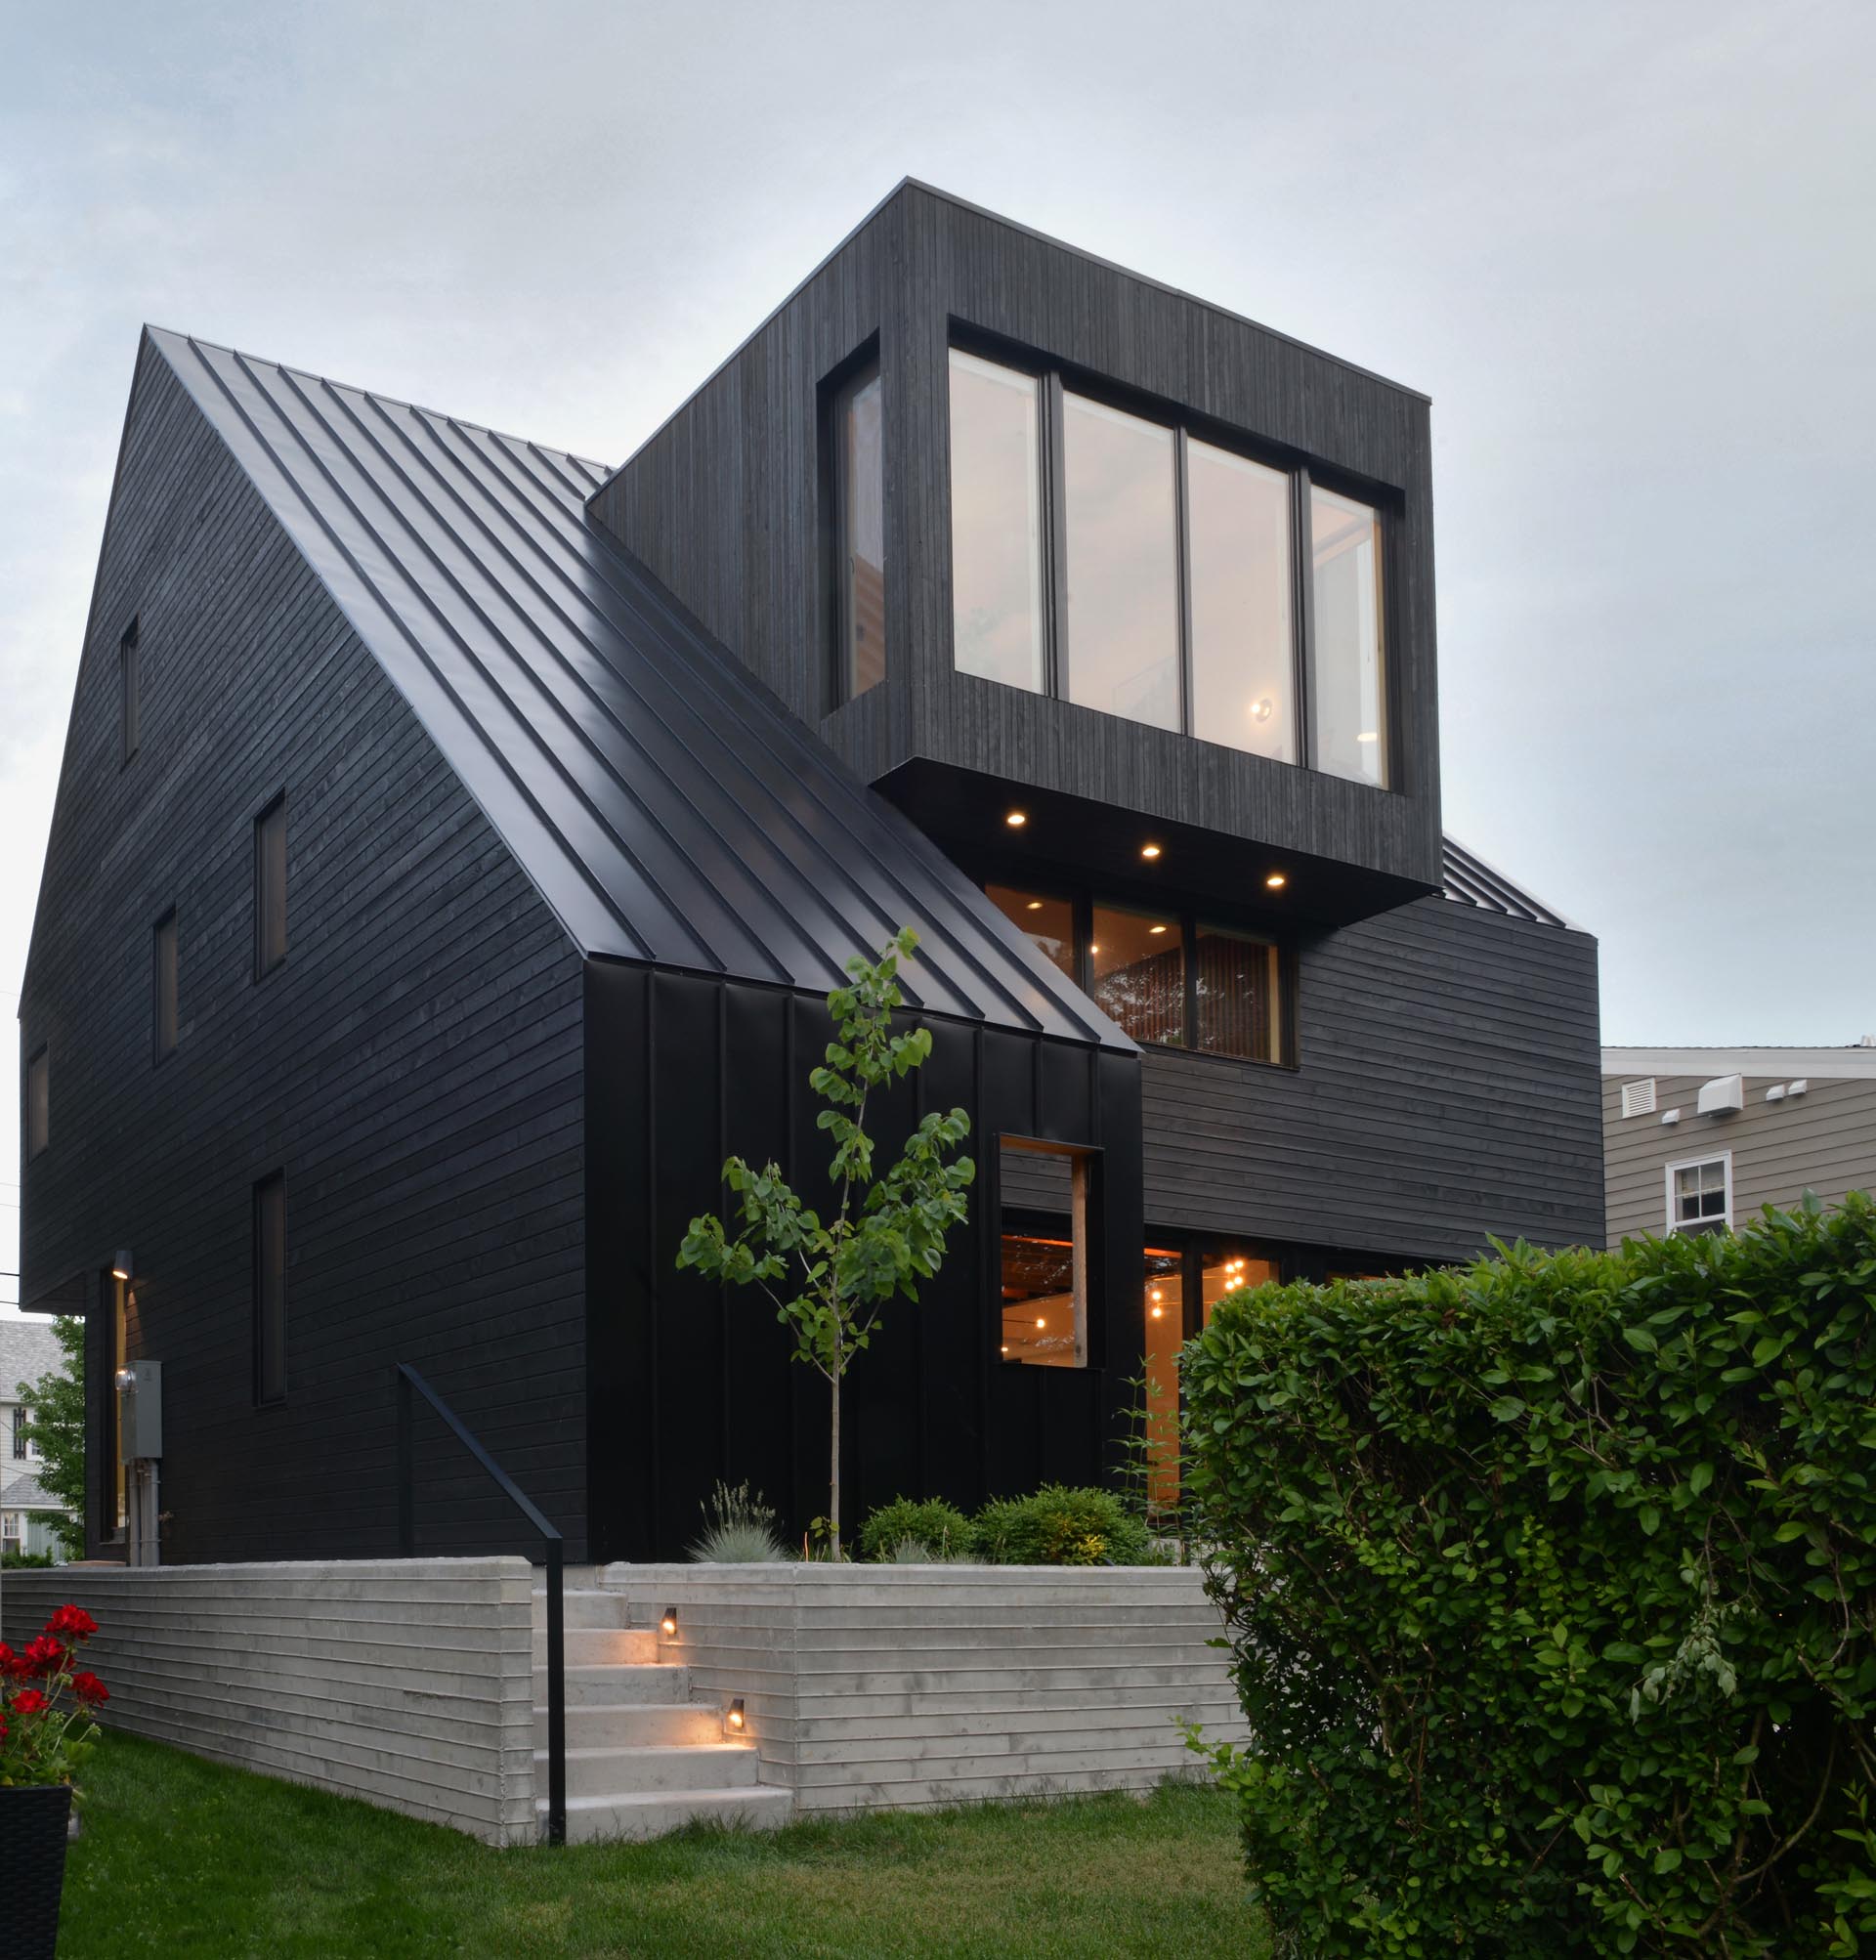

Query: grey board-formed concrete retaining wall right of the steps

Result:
[600,1564,1245,1811]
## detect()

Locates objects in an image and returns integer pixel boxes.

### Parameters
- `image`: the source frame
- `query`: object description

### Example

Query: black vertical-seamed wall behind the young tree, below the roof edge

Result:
[586,960,1141,1558]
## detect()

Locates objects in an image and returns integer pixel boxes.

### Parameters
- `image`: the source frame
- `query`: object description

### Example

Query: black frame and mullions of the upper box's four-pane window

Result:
[947,329,1405,793]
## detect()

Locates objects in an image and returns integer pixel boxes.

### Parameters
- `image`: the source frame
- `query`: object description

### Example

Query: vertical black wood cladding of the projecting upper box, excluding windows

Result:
[592,185,1441,893]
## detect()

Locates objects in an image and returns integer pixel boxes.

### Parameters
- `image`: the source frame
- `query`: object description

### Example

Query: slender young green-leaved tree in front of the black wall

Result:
[678,925,976,1558]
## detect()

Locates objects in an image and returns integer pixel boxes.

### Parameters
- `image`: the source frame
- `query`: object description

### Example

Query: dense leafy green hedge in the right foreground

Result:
[1184,1198,1876,1960]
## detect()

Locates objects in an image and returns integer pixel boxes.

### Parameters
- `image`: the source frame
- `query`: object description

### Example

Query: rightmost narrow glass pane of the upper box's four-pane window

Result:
[1309,486,1387,786]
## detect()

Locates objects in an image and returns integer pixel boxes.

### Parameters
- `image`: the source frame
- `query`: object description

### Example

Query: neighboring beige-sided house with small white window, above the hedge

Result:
[1601,1035,1876,1245]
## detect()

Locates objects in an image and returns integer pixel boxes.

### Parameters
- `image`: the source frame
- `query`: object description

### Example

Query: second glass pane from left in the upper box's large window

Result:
[1062,394,1180,729]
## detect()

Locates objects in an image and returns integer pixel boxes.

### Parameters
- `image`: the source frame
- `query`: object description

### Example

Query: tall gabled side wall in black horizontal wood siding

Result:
[21,337,586,1560]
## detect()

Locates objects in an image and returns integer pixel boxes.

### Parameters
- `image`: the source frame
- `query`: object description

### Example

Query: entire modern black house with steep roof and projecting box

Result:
[21,183,1601,1562]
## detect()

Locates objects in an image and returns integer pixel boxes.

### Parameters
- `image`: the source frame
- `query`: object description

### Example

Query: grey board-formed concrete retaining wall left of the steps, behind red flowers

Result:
[0,1558,537,1845]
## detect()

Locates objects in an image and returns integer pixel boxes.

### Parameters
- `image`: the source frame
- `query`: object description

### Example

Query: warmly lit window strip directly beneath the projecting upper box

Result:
[984,884,1290,1062]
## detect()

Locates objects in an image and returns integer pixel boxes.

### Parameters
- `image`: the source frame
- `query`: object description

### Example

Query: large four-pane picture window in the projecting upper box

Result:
[951,349,1389,788]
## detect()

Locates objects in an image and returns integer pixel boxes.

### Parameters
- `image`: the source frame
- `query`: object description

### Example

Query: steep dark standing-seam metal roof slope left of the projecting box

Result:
[149,329,1133,1050]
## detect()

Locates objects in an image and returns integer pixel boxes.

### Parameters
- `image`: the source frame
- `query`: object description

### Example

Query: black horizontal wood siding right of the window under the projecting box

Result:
[1143,898,1603,1260]
